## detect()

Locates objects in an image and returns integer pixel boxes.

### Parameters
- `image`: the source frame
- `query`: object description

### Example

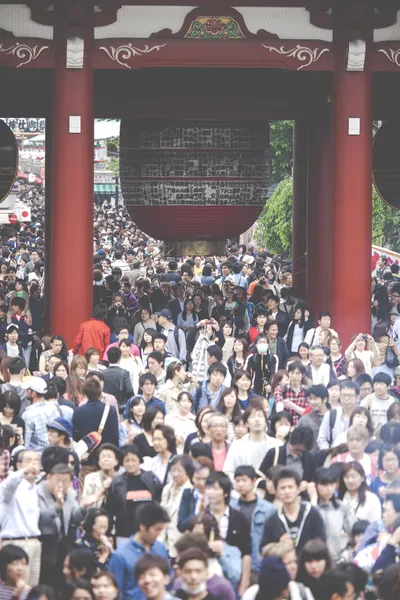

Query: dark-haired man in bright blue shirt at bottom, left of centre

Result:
[108,501,169,600]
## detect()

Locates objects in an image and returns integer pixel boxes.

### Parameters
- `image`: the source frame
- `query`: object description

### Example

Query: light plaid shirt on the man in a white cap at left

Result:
[24,401,61,454]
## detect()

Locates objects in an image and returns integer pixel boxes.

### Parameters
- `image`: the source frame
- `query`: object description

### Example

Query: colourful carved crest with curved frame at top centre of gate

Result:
[150,5,279,40]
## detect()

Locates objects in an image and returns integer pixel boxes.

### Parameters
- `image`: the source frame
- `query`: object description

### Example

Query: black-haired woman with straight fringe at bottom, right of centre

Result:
[297,539,332,598]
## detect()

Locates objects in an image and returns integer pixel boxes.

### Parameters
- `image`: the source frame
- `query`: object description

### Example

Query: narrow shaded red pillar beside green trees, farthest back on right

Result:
[292,119,308,298]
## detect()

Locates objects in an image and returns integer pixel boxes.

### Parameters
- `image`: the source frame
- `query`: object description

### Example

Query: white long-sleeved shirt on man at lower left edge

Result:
[0,471,40,540]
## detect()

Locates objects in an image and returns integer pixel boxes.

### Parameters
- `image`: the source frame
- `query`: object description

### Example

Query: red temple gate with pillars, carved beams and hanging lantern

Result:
[0,0,400,343]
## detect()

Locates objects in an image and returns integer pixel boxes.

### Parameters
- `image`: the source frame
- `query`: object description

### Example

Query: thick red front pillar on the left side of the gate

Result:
[50,1,94,348]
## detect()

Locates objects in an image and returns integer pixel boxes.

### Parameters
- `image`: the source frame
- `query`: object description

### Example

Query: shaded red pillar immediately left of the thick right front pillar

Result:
[307,109,332,318]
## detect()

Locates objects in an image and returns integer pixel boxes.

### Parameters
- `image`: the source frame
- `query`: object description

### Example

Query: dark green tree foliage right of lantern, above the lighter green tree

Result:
[269,121,293,184]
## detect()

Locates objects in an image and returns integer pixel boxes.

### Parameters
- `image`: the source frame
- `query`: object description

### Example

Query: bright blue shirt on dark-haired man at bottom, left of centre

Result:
[108,535,169,600]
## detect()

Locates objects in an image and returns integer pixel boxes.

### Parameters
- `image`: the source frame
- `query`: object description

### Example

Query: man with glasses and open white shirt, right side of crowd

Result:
[317,381,360,450]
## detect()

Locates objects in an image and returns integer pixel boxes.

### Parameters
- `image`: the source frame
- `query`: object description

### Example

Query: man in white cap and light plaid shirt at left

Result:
[22,377,60,454]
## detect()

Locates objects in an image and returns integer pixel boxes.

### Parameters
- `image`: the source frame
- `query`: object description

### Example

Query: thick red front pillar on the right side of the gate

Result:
[331,9,372,344]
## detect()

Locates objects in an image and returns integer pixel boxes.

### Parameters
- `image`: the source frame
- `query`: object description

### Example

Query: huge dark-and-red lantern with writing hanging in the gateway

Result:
[120,120,270,255]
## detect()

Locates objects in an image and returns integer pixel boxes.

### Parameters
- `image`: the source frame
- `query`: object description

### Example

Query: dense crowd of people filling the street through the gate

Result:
[0,184,400,600]
